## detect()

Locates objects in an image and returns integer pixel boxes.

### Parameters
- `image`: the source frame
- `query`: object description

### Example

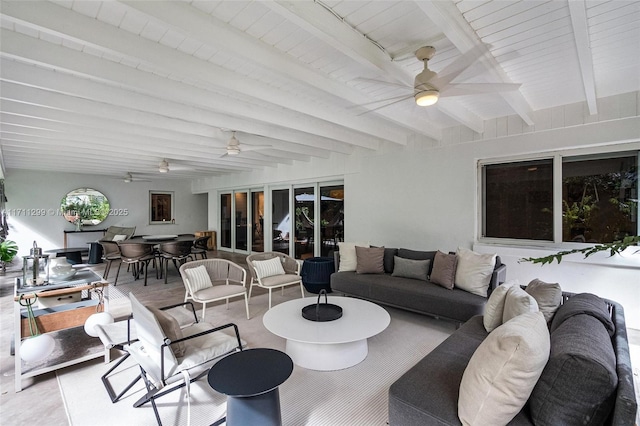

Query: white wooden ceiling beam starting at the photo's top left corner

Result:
[3,2,406,149]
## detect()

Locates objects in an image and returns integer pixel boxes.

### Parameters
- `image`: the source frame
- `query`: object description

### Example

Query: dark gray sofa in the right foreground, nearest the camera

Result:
[389,293,637,426]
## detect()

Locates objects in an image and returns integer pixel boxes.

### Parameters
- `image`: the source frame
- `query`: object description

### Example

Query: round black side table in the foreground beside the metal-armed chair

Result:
[208,348,293,426]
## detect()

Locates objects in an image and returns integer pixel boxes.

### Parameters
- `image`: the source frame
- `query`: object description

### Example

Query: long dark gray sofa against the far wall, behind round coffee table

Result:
[331,248,507,323]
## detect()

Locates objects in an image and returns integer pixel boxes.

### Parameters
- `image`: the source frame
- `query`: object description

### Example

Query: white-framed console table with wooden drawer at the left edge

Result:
[14,270,109,392]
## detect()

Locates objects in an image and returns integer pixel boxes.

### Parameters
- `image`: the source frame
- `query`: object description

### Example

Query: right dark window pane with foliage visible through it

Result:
[562,154,638,243]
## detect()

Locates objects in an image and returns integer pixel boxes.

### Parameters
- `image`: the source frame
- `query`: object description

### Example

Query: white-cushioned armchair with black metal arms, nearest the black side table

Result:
[124,293,246,425]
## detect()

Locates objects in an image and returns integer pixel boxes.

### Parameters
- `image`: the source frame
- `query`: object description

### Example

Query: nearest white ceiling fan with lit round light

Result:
[360,46,521,112]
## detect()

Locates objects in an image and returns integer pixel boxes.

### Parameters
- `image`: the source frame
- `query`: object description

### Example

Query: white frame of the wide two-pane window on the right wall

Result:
[476,144,640,249]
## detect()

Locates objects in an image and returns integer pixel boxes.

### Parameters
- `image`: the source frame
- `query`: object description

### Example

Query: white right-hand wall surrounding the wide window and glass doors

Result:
[193,93,640,329]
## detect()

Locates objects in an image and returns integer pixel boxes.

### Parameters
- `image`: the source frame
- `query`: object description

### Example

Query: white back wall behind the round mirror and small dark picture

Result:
[5,169,207,256]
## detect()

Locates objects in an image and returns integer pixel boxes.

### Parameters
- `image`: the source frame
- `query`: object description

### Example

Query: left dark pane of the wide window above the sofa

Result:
[483,159,553,240]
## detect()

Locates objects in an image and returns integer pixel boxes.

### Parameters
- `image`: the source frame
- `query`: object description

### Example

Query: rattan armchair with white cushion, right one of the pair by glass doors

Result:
[247,251,304,309]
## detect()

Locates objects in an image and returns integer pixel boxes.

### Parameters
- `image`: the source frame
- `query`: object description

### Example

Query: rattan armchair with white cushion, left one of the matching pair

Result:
[180,259,249,319]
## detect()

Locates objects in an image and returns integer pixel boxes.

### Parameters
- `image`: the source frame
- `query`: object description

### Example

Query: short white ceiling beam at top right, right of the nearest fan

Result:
[568,0,598,115]
